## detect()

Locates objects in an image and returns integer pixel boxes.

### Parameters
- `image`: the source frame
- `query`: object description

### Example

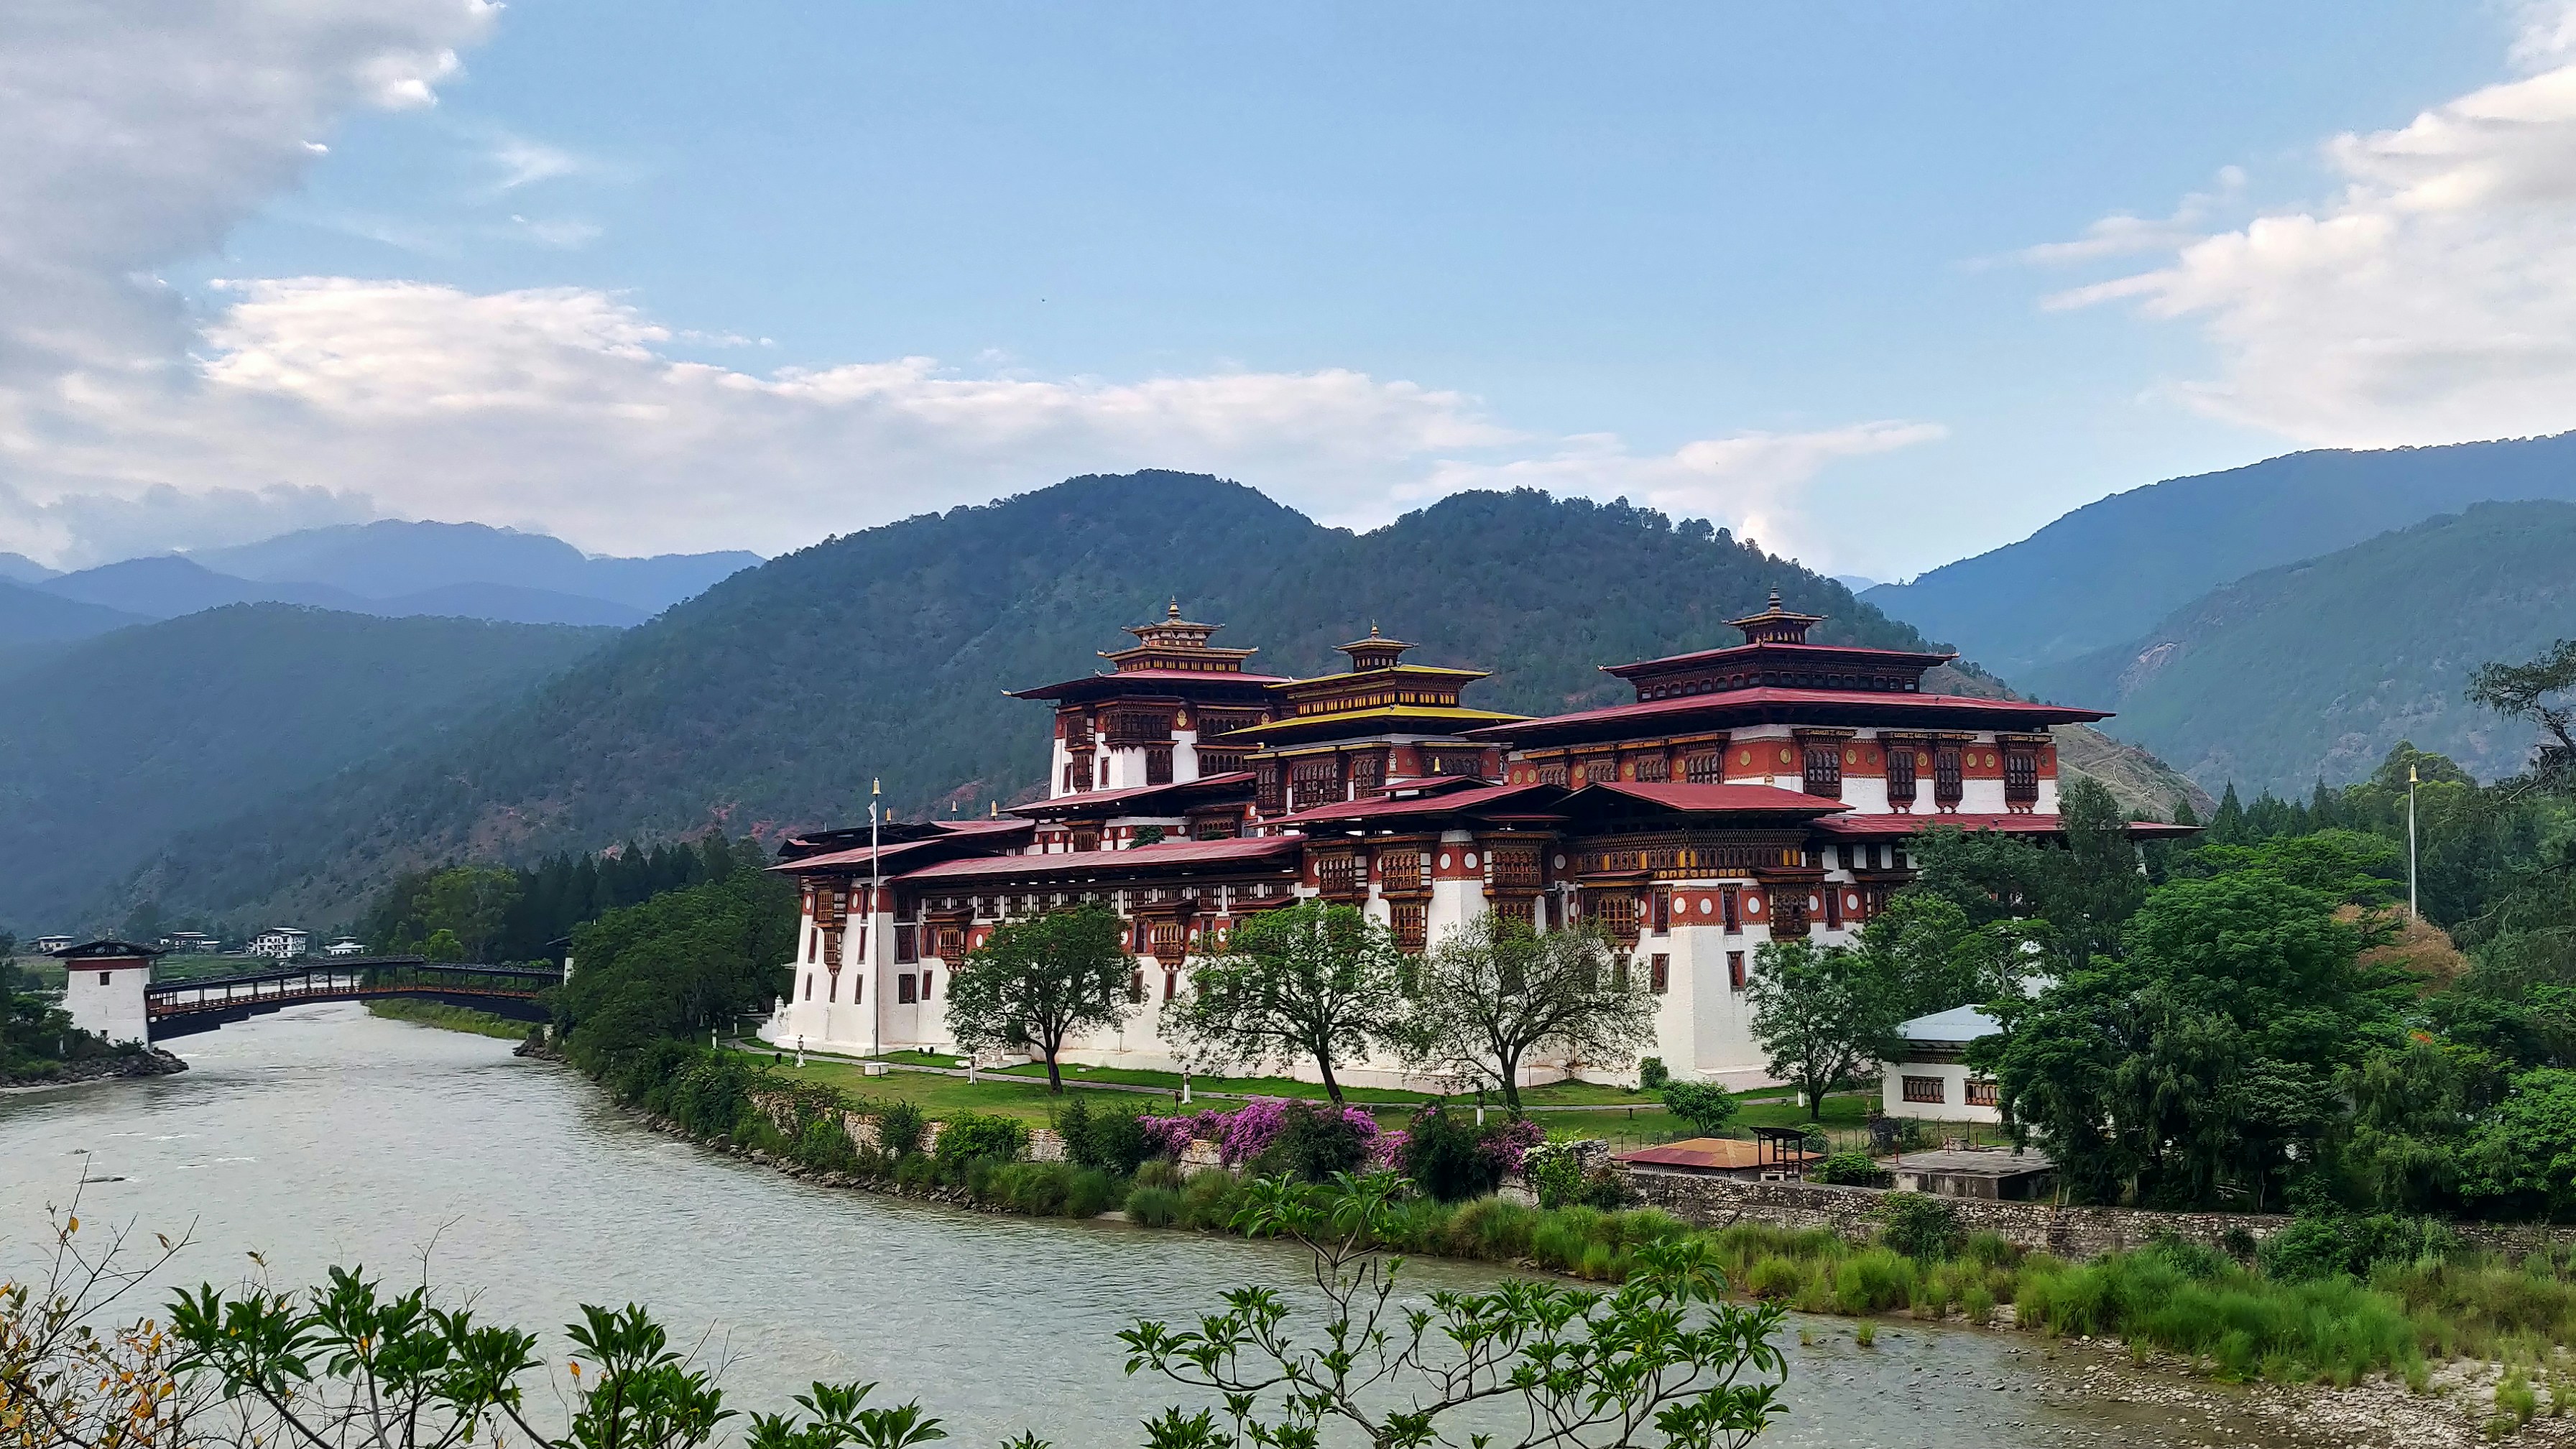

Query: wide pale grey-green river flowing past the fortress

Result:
[0,1006,2328,1449]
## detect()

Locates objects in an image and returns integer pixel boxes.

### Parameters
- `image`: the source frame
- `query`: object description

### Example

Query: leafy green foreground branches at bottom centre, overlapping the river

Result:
[1118,1174,1788,1449]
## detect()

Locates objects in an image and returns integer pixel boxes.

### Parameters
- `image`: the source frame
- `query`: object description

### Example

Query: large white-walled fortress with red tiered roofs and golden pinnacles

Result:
[762,595,2171,1086]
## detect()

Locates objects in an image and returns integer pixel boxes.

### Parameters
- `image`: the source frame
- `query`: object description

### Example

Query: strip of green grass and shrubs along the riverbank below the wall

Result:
[605,1042,2576,1384]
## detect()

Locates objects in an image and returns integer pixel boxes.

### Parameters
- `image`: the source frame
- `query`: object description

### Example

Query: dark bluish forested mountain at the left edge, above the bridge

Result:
[0,600,613,934]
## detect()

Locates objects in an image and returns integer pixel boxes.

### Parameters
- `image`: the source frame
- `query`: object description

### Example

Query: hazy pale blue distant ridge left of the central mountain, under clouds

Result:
[190,520,760,615]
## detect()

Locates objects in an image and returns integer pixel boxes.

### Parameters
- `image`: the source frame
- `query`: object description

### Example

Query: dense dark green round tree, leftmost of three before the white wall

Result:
[948,906,1131,1091]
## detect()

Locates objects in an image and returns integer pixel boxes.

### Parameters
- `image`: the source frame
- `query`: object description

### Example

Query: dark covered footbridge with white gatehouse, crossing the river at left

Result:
[54,942,567,1042]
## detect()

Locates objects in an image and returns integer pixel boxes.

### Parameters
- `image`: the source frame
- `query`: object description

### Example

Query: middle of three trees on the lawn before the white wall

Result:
[1162,901,1406,1101]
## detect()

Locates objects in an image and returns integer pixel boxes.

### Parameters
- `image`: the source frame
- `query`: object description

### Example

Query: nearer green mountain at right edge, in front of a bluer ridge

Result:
[2020,502,2576,792]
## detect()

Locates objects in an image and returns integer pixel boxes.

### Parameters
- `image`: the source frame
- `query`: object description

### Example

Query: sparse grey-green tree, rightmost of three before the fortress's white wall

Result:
[1396,911,1654,1112]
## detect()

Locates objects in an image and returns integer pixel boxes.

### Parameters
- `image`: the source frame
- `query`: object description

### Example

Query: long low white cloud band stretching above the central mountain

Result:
[13,278,1940,556]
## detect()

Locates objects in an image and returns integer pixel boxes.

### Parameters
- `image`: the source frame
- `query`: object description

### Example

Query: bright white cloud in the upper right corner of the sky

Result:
[2051,5,2576,448]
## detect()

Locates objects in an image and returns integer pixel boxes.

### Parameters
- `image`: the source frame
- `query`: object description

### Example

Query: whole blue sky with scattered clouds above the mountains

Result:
[0,0,2576,579]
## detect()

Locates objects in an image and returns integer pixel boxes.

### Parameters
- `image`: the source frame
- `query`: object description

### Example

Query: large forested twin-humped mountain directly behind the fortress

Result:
[119,473,2194,916]
